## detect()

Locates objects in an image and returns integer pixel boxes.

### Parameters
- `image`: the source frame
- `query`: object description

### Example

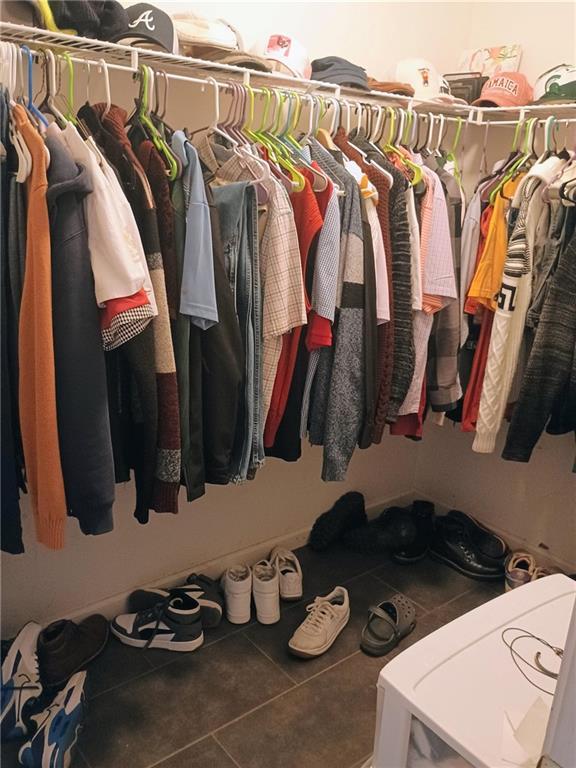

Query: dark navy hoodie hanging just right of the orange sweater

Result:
[46,124,114,534]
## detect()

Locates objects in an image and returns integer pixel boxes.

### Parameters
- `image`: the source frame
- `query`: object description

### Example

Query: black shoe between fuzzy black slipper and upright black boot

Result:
[342,507,416,555]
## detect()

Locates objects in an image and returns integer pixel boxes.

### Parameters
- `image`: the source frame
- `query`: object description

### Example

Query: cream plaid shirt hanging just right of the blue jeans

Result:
[196,136,306,421]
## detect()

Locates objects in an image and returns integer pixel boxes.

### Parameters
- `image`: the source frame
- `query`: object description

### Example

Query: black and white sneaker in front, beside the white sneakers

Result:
[110,592,204,653]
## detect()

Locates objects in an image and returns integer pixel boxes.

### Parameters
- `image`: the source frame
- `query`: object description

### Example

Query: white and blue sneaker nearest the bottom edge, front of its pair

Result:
[18,672,86,768]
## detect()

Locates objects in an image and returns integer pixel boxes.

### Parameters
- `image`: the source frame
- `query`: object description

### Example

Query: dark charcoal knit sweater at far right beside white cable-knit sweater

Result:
[502,226,576,461]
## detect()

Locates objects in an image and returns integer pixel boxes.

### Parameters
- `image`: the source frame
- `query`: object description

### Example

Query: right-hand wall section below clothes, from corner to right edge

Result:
[416,422,576,572]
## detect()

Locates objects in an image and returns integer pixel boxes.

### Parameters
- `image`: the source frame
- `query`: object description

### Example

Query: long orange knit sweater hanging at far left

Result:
[13,105,66,549]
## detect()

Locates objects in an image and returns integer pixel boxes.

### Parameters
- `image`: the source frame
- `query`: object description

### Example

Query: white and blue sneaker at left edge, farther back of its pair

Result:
[0,621,42,741]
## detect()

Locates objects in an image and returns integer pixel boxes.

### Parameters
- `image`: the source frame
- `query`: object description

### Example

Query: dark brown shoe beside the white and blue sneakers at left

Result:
[37,614,108,687]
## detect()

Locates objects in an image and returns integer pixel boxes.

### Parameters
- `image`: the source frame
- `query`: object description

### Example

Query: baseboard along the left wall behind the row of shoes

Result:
[62,492,414,624]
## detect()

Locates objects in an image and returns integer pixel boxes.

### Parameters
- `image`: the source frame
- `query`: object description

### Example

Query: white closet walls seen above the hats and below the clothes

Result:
[2,2,576,635]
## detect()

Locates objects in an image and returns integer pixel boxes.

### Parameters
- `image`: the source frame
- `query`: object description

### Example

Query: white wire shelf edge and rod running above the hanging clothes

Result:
[0,22,576,126]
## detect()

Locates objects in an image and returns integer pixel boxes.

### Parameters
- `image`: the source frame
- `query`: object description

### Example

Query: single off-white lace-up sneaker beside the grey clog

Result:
[288,587,350,659]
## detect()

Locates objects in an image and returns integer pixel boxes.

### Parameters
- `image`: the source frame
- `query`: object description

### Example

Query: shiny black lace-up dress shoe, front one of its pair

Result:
[430,515,504,581]
